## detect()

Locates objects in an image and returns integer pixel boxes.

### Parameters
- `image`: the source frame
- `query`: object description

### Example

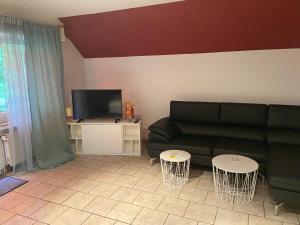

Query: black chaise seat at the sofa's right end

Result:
[267,144,300,192]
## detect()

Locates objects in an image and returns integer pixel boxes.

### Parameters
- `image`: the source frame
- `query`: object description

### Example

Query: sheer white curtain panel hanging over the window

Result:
[0,16,33,170]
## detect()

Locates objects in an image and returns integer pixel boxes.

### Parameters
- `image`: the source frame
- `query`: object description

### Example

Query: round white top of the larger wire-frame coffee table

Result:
[212,154,258,173]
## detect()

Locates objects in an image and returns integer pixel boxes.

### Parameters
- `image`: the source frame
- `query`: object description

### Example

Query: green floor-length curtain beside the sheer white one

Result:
[23,22,73,168]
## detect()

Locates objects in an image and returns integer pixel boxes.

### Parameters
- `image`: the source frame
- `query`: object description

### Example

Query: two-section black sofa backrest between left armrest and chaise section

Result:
[170,101,267,141]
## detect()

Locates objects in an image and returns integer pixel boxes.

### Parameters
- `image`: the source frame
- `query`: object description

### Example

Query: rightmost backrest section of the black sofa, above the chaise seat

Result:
[267,105,300,145]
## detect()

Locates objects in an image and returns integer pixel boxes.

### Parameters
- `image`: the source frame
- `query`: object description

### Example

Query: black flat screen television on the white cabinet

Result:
[72,90,122,120]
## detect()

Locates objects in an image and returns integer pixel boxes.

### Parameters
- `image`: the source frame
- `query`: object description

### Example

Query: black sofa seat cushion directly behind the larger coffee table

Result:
[213,138,267,163]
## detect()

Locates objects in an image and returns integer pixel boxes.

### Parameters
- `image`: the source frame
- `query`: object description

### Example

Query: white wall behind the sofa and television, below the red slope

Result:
[84,49,300,138]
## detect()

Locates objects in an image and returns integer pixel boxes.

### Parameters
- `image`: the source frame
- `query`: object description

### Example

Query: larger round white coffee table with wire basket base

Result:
[212,154,258,204]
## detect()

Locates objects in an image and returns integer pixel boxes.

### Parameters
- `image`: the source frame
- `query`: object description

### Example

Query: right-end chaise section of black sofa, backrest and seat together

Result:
[267,105,300,205]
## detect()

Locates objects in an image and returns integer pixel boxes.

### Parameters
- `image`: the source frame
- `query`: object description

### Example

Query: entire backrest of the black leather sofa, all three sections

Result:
[170,101,300,145]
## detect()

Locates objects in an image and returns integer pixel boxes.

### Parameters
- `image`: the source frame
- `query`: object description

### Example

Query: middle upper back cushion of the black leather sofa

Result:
[220,103,267,127]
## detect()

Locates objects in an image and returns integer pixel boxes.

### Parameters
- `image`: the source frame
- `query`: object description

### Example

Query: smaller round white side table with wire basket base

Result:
[160,150,191,186]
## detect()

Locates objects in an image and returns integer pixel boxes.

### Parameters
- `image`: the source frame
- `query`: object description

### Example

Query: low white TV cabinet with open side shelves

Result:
[67,119,141,156]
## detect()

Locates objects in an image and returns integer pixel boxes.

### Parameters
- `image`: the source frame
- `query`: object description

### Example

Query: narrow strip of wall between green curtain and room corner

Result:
[62,38,86,107]
